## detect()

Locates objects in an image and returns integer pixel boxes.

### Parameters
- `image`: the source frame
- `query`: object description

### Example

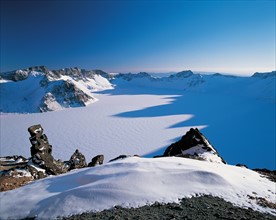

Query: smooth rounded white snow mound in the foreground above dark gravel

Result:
[0,157,275,219]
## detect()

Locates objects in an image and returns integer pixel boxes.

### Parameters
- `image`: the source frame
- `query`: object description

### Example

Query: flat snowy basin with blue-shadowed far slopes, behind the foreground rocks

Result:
[0,74,276,169]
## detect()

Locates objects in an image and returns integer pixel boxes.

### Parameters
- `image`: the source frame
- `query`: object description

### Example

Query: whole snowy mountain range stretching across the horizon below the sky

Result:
[0,66,276,113]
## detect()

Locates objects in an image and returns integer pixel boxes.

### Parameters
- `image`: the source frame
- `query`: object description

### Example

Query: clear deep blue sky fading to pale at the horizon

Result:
[1,0,276,74]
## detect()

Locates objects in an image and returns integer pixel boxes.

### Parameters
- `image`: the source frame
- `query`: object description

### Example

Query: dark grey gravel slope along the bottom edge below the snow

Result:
[60,196,275,220]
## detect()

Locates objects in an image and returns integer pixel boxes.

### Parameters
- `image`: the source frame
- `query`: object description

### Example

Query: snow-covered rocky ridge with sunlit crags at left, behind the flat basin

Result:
[0,66,113,113]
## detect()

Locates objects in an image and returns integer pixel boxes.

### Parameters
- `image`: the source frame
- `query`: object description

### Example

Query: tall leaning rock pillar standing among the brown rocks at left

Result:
[28,125,68,175]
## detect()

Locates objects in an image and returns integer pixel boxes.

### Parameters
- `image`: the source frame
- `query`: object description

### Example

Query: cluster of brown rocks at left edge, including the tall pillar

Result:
[0,124,104,192]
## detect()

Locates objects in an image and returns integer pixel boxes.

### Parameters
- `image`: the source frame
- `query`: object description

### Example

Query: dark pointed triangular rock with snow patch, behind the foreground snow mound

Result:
[163,128,226,163]
